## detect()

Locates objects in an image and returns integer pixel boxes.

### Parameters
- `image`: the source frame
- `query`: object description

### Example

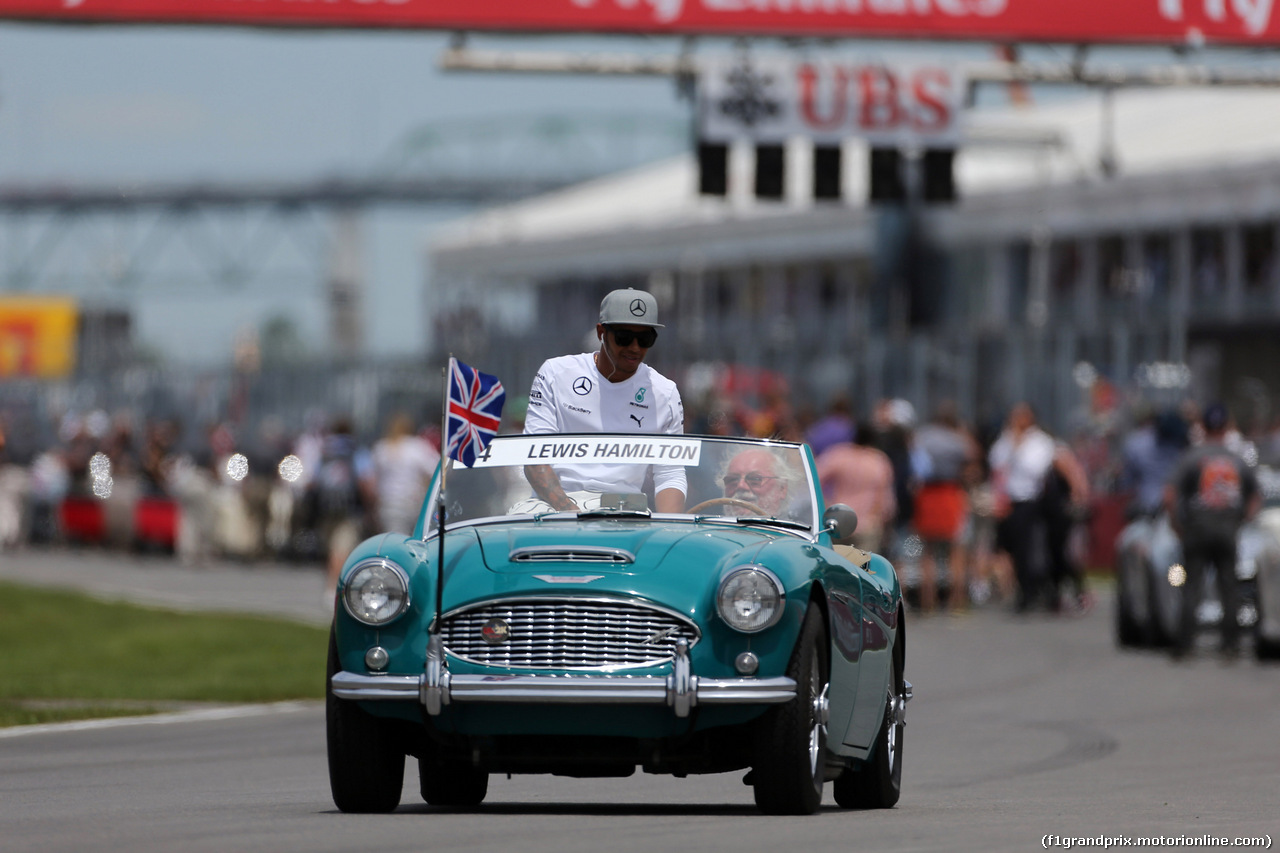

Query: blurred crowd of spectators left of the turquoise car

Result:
[0,411,439,573]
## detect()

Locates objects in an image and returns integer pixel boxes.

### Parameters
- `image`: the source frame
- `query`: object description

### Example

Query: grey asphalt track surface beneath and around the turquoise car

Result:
[0,553,1280,853]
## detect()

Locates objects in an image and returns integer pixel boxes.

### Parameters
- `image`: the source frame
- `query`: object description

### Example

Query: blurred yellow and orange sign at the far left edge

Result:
[0,296,78,379]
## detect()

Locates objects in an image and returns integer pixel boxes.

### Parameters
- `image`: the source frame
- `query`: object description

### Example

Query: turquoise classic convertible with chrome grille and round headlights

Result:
[326,434,911,815]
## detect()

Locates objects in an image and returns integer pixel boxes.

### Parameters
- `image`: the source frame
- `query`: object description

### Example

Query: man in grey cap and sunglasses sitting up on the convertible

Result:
[512,288,689,512]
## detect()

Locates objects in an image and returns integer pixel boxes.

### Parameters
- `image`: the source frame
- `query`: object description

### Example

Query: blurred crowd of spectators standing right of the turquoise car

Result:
[690,381,1280,613]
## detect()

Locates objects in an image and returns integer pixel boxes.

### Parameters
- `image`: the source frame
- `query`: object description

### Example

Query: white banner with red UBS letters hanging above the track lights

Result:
[698,58,965,147]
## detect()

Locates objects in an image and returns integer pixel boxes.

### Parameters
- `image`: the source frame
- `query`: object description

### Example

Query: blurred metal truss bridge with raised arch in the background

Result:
[0,115,690,298]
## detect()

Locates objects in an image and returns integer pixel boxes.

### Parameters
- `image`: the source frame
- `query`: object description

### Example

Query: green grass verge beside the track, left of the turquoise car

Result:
[0,583,328,726]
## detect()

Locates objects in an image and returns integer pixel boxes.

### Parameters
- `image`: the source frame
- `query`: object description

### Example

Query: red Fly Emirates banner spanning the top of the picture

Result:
[0,0,1280,45]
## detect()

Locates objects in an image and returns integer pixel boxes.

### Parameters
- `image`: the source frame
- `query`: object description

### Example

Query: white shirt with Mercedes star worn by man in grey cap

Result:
[525,352,689,494]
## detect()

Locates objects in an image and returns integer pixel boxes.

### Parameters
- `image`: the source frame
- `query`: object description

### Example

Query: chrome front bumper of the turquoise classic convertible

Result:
[330,643,796,717]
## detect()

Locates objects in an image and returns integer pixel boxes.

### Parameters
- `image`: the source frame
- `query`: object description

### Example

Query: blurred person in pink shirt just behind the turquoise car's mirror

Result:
[815,429,897,552]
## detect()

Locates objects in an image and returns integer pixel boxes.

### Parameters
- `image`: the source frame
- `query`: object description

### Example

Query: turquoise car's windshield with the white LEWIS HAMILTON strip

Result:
[428,433,818,533]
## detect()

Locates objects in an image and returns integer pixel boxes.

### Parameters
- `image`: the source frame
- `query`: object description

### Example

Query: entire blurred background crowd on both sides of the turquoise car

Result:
[0,386,1280,612]
